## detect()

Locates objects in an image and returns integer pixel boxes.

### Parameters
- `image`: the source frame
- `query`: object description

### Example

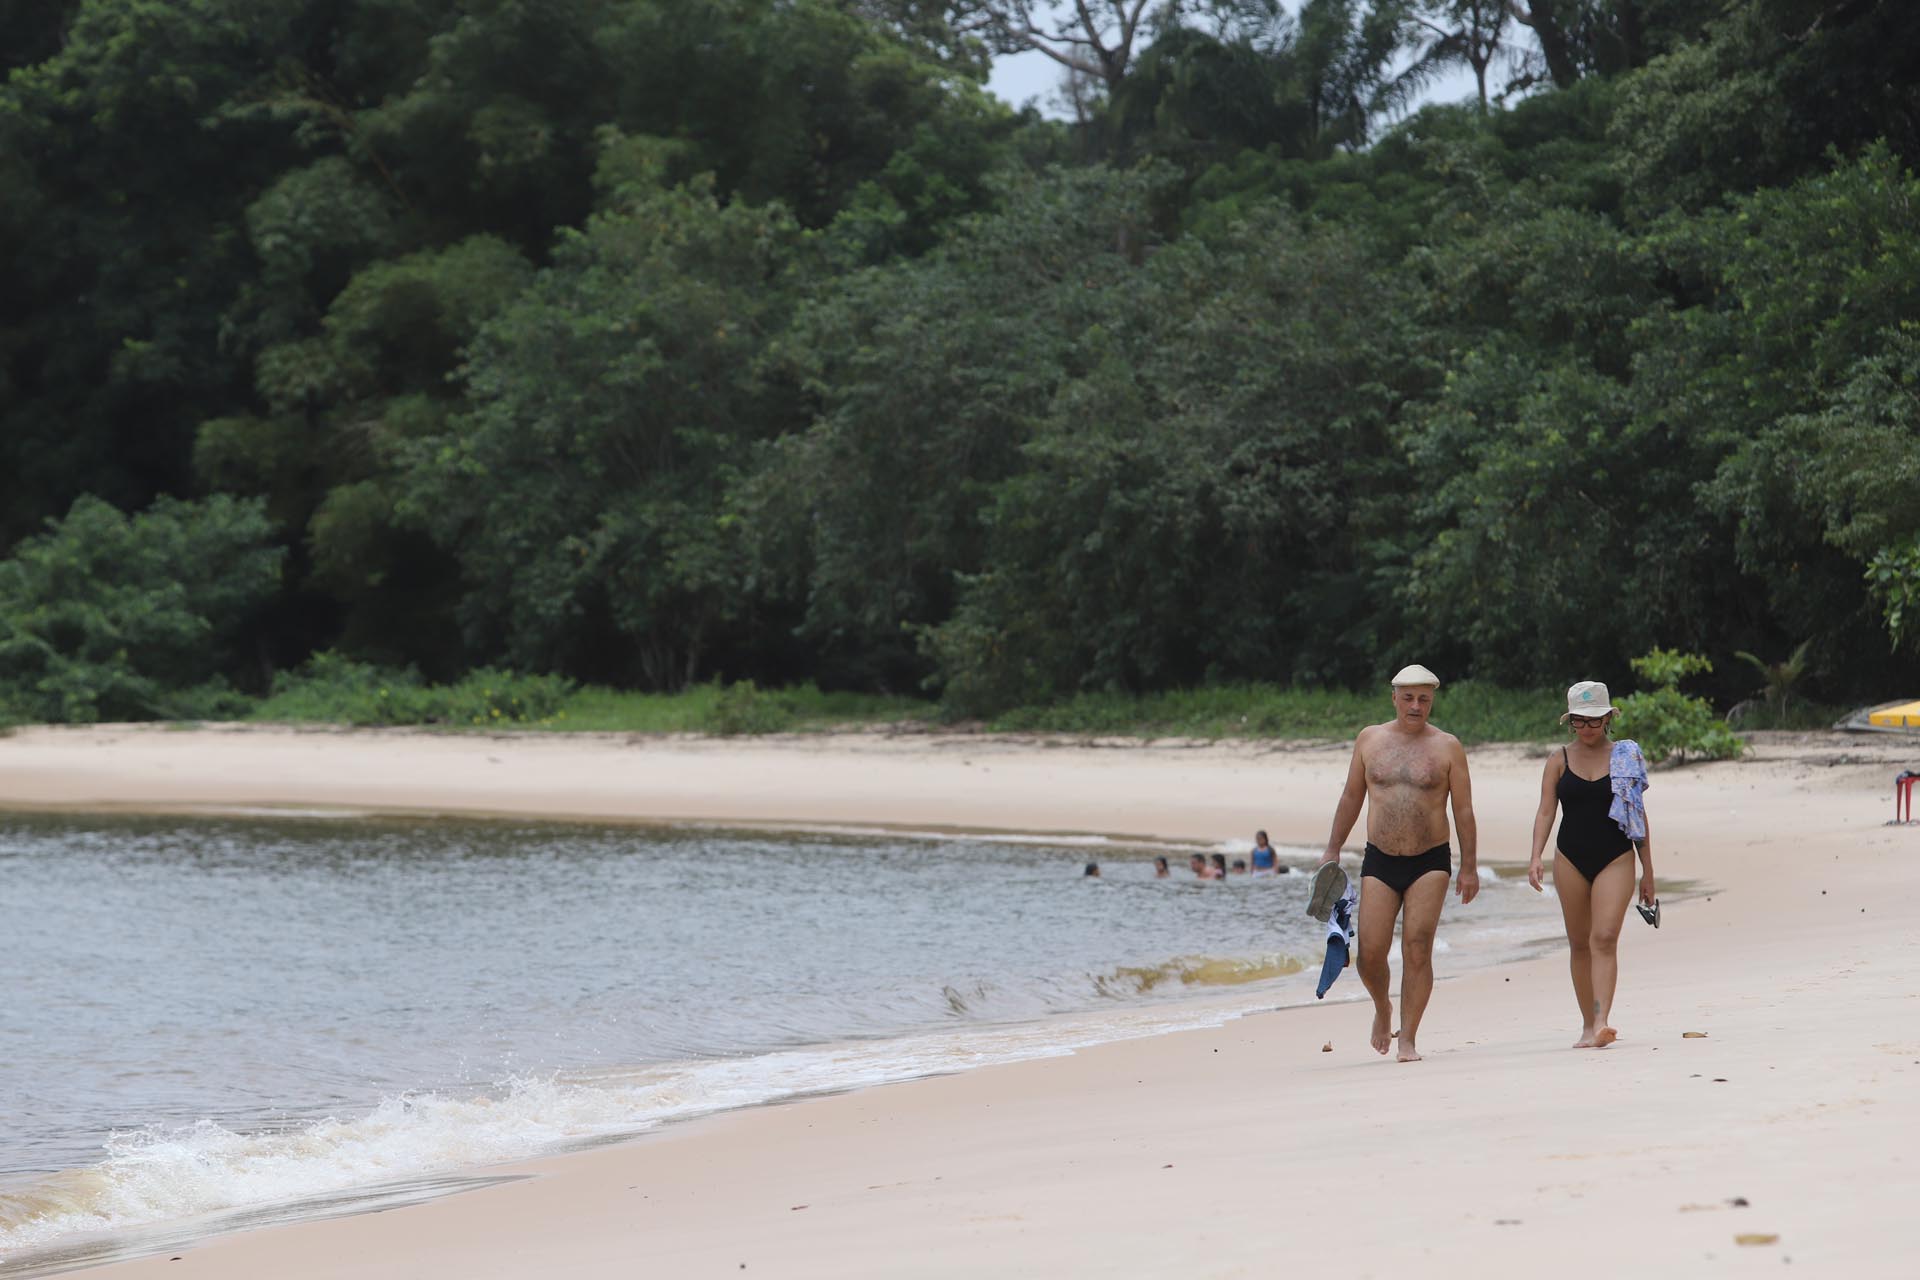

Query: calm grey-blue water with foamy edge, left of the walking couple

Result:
[0,816,1542,1274]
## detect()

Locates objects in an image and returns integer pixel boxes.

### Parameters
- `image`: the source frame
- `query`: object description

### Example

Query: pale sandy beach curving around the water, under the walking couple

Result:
[0,714,1920,1280]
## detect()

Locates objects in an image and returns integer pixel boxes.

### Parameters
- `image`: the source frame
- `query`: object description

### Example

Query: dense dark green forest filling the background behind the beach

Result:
[0,0,1920,722]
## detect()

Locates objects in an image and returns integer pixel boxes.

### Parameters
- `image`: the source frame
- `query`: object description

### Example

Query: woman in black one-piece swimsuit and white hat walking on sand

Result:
[1526,679,1659,1050]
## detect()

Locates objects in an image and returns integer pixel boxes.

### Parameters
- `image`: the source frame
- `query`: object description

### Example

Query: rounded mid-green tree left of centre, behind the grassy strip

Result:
[405,175,799,689]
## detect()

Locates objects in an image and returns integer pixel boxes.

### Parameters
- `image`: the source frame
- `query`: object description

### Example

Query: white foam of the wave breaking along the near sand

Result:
[0,1000,1265,1259]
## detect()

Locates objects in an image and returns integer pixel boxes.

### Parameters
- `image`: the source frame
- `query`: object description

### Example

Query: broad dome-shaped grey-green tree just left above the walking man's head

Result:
[925,209,1427,712]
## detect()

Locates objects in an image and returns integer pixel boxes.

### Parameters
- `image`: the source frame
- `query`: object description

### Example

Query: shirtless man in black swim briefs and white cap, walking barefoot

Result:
[1321,664,1480,1063]
